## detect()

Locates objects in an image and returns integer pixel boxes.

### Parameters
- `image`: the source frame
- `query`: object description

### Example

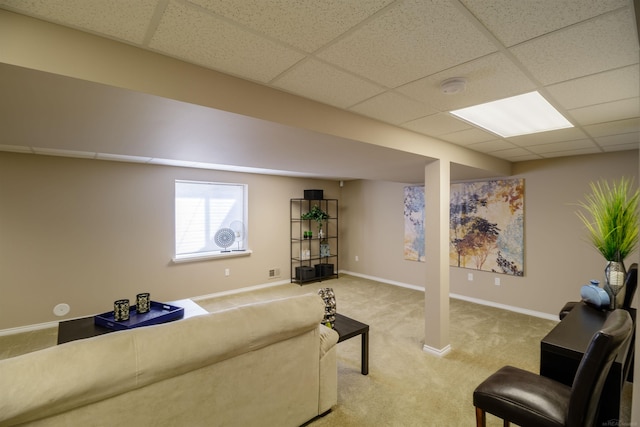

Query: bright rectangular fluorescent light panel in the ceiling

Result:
[451,92,573,138]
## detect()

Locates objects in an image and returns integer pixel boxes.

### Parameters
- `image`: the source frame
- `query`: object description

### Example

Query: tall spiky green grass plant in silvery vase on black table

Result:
[576,177,640,309]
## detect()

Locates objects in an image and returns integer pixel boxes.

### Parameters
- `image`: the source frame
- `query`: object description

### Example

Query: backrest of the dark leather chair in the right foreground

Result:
[567,309,633,427]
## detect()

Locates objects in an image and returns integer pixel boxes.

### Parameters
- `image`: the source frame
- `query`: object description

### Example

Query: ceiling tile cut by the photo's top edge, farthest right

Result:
[460,0,629,46]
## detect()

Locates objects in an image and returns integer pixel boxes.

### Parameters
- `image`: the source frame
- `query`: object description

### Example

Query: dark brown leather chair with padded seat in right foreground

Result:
[473,309,633,427]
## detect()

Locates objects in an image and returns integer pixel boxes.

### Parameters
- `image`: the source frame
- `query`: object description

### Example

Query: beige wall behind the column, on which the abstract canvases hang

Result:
[340,151,638,316]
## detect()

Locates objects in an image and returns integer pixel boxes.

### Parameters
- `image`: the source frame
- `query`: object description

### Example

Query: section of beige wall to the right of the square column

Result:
[451,151,638,315]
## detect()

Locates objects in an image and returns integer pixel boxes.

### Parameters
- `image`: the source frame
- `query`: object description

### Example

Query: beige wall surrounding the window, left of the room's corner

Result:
[0,152,340,330]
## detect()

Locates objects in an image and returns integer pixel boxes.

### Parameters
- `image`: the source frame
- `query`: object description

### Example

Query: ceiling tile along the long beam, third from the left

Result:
[273,59,384,108]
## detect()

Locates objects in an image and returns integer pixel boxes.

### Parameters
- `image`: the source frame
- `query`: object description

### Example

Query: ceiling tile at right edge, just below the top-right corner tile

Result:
[510,7,638,85]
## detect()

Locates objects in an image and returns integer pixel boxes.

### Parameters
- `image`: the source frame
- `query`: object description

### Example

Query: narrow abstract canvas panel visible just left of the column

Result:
[404,185,425,262]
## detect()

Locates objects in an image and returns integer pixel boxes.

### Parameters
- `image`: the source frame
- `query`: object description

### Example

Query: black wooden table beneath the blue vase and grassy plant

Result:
[540,303,636,425]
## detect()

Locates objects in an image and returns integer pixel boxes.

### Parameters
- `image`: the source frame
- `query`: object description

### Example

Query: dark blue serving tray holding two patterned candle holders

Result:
[94,301,184,331]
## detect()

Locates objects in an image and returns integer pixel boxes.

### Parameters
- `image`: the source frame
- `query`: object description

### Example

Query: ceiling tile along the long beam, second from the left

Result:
[149,2,304,83]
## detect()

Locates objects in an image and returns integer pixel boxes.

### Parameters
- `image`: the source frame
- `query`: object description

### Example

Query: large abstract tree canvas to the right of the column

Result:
[448,179,524,276]
